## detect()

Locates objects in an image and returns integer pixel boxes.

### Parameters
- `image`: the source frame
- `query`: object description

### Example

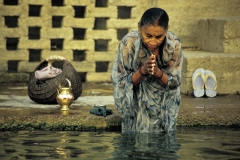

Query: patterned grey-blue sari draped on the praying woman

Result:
[111,31,183,133]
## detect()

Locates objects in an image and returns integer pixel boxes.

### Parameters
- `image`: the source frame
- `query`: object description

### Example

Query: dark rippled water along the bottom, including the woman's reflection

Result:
[0,128,240,160]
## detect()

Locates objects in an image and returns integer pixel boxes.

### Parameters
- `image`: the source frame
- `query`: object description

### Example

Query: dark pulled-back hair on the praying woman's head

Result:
[139,8,169,29]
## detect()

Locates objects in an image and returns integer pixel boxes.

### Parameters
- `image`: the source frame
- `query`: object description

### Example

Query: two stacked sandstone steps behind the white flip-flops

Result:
[181,16,240,94]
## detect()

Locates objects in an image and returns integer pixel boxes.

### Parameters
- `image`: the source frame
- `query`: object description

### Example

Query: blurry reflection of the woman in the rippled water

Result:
[114,133,181,159]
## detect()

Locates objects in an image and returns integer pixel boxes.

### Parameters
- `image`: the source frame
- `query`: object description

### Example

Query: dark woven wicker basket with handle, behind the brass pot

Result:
[28,56,82,104]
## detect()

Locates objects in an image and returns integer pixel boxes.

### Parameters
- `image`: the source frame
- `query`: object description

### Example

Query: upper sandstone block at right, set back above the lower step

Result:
[199,16,240,54]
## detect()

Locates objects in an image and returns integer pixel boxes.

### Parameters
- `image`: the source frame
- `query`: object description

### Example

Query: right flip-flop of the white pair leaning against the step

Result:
[204,70,217,97]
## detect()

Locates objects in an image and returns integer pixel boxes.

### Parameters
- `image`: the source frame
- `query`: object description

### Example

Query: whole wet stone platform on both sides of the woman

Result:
[0,83,240,131]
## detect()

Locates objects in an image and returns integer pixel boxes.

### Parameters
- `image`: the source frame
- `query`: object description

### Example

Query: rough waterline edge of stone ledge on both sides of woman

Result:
[0,115,240,131]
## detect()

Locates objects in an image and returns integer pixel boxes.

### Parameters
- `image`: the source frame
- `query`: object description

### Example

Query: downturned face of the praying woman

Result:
[138,25,167,51]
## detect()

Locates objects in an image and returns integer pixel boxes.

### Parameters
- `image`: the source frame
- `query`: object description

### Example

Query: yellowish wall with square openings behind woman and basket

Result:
[0,0,240,83]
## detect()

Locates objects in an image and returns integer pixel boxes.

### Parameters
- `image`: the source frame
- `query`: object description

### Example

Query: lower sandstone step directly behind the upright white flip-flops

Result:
[181,50,240,94]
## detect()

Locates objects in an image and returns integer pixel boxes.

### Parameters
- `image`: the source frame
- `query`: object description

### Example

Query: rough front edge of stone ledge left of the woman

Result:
[0,115,121,131]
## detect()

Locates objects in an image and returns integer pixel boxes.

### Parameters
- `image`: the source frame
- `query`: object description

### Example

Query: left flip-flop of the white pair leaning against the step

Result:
[192,68,205,97]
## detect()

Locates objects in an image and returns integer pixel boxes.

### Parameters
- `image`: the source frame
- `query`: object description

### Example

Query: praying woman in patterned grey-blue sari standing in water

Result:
[111,8,183,133]
